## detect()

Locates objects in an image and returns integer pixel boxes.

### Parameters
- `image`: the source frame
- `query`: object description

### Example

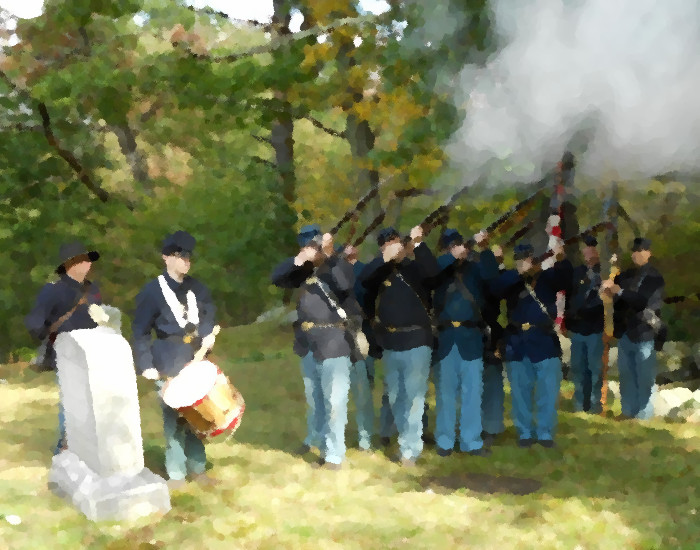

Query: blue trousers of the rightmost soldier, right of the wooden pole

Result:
[617,334,656,420]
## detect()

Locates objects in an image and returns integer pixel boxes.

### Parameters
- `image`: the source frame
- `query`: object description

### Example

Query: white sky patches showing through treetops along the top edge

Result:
[0,0,389,21]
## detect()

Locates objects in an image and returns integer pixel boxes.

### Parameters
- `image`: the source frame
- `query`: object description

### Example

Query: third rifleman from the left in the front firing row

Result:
[432,229,498,456]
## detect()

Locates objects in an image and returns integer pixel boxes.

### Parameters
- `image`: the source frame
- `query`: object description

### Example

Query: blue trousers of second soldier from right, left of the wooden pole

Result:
[569,332,603,413]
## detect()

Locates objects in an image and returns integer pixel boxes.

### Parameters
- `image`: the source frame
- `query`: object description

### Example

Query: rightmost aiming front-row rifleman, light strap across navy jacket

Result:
[491,244,570,448]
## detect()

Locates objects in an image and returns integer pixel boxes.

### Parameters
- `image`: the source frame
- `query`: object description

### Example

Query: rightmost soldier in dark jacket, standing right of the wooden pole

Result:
[602,237,665,419]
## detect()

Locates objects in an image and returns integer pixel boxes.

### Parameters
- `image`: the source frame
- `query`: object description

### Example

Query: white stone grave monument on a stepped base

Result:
[49,326,170,521]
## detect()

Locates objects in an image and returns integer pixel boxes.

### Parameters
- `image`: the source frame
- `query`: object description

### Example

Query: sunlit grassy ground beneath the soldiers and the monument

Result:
[0,325,700,550]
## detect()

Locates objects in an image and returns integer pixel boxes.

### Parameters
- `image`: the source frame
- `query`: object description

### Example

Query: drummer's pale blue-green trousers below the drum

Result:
[156,380,207,480]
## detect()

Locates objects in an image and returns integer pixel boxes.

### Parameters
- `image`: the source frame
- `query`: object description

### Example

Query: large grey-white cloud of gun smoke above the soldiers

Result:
[449,0,700,185]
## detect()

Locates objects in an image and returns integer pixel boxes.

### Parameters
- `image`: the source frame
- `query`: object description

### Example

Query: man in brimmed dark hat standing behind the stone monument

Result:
[24,242,102,455]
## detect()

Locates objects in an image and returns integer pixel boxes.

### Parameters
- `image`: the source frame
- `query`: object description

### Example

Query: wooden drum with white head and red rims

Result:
[161,361,245,438]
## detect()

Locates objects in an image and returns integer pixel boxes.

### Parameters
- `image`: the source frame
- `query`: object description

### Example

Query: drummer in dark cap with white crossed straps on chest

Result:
[132,231,216,489]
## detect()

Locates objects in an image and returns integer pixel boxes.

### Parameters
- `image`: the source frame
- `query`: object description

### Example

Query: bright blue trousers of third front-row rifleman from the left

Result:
[435,344,484,452]
